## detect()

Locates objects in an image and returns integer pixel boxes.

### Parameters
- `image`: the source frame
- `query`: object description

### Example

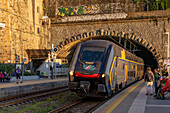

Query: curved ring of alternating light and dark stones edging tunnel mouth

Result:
[57,29,163,68]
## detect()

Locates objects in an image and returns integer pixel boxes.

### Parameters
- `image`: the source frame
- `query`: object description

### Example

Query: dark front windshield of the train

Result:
[80,47,105,62]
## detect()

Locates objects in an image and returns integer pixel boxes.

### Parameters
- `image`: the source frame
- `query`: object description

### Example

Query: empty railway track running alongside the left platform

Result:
[0,86,69,108]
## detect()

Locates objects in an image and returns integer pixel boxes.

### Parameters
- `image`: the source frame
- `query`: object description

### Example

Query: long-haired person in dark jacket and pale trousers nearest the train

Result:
[144,67,154,95]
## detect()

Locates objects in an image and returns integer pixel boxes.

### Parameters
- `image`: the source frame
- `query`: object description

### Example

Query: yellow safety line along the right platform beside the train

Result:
[100,80,143,113]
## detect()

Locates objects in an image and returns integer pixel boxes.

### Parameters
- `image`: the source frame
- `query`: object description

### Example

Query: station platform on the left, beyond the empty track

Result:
[0,77,68,98]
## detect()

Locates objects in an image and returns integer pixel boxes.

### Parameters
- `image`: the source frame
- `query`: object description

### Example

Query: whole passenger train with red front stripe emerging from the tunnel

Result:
[69,40,144,97]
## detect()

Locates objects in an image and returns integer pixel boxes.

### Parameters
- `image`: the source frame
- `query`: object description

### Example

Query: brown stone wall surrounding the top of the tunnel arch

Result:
[50,18,170,64]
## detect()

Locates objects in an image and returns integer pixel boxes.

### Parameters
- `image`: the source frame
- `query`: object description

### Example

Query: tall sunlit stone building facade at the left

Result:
[0,0,50,63]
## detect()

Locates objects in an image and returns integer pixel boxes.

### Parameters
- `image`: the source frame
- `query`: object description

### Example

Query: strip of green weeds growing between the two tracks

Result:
[0,92,79,113]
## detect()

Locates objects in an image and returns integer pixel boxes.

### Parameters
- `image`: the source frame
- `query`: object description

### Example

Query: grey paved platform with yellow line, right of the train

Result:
[93,80,170,113]
